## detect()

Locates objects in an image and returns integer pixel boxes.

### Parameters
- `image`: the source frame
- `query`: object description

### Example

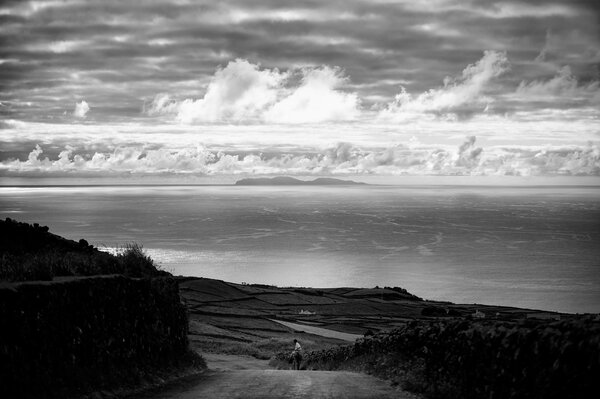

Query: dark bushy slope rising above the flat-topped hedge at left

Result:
[0,218,169,281]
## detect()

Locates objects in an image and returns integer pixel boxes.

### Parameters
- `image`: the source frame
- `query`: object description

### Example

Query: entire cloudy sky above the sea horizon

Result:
[0,0,600,183]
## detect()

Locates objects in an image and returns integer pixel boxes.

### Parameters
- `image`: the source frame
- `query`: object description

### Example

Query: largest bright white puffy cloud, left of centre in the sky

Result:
[147,59,358,124]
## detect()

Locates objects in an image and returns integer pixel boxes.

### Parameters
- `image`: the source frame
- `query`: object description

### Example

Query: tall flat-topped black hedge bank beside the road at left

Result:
[0,276,204,398]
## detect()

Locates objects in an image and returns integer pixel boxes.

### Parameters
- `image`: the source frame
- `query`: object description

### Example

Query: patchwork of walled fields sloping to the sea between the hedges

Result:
[179,277,569,359]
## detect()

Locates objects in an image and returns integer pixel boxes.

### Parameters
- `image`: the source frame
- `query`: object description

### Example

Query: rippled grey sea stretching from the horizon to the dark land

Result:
[0,186,600,313]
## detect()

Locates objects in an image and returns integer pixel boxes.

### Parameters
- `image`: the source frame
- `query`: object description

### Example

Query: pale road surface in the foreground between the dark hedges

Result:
[140,370,412,399]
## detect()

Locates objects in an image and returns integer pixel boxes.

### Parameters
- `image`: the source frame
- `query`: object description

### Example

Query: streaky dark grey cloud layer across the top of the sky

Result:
[0,0,600,122]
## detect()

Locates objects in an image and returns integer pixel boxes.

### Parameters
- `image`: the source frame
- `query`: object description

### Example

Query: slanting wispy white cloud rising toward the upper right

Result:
[380,51,510,120]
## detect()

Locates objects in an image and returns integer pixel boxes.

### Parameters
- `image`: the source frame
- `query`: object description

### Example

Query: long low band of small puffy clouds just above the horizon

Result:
[0,141,600,176]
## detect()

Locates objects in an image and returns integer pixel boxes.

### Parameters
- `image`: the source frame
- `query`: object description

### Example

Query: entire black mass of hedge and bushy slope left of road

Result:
[0,219,205,398]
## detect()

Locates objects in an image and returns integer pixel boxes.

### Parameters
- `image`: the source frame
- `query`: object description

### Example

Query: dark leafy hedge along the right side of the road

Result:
[272,316,600,399]
